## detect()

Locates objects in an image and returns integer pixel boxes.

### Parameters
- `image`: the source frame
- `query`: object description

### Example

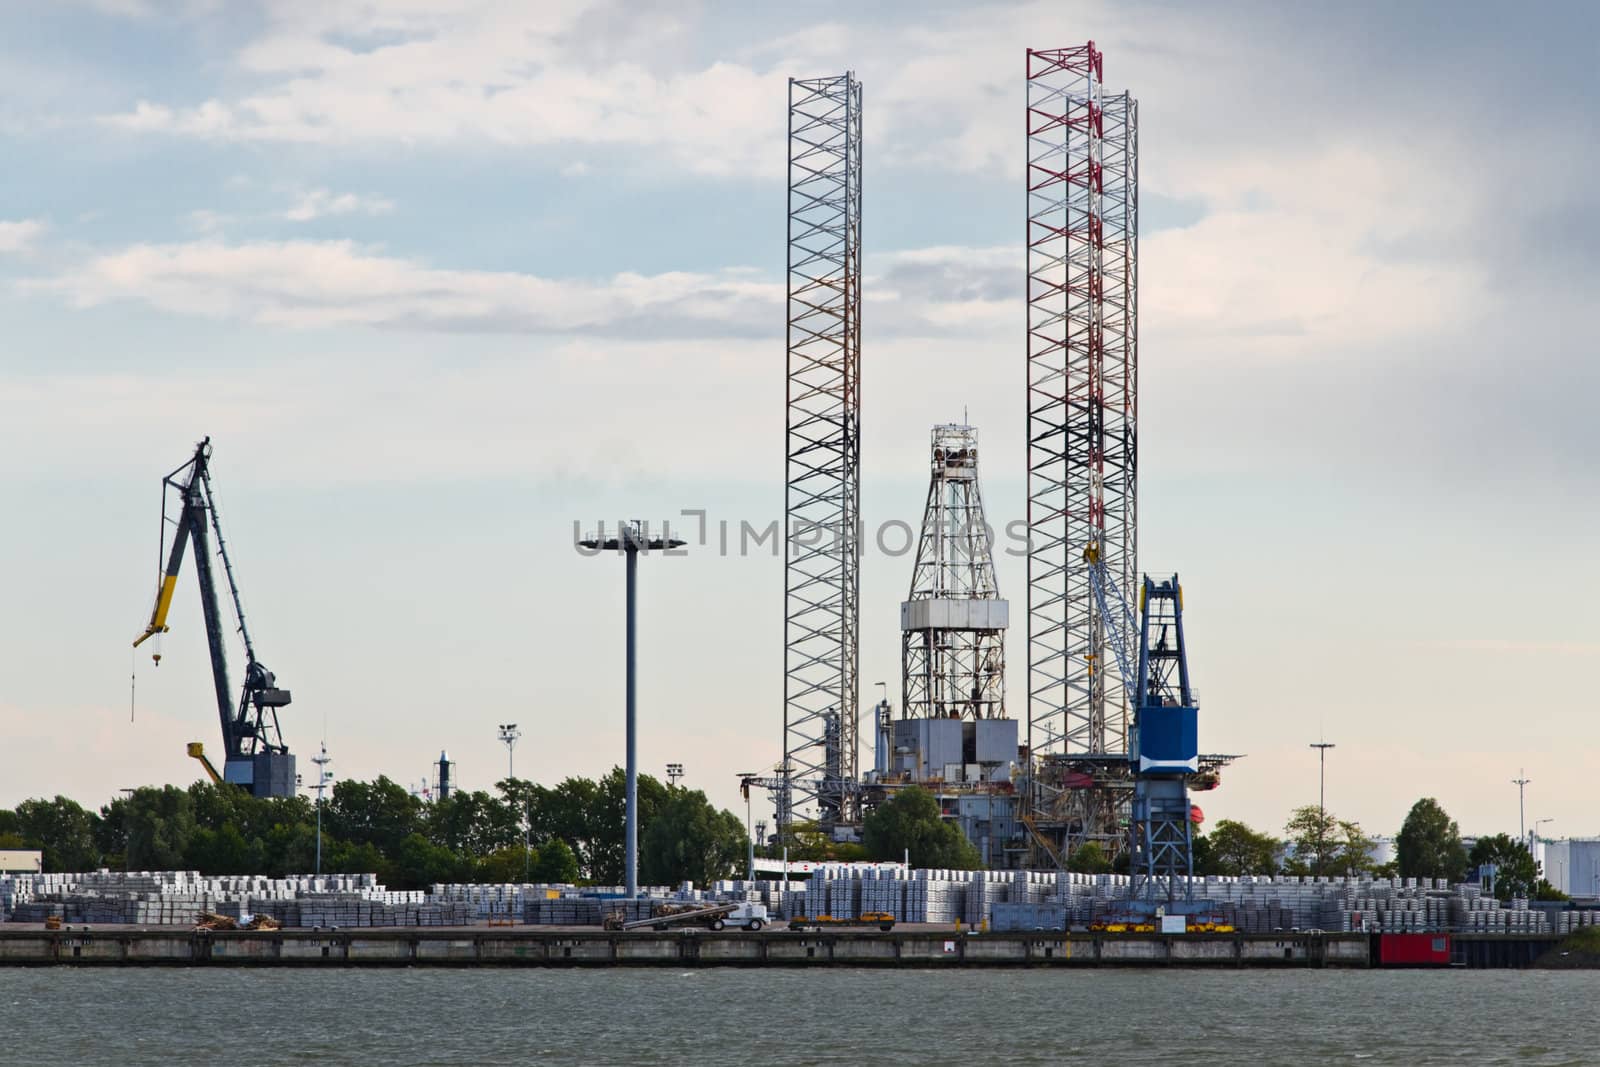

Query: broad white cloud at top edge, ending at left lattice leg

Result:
[93,2,784,174]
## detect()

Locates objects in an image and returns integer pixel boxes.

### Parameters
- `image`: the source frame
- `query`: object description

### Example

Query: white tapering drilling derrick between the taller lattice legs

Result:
[901,426,1010,720]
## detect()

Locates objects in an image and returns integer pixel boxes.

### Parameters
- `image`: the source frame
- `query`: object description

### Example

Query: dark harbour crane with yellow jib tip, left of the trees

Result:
[133,437,294,797]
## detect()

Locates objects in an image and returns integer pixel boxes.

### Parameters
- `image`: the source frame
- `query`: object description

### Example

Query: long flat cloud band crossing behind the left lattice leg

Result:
[24,236,1021,338]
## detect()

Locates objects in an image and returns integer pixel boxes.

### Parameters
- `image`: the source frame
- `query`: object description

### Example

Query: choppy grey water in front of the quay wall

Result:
[0,969,1600,1067]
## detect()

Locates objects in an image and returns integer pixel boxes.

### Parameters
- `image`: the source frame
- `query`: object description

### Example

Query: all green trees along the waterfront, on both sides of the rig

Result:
[0,768,1560,899]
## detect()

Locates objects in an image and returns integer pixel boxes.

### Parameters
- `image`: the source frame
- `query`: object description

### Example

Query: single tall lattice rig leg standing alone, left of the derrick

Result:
[774,72,861,837]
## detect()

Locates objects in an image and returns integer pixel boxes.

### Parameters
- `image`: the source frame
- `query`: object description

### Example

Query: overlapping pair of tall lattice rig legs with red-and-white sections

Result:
[1024,42,1139,862]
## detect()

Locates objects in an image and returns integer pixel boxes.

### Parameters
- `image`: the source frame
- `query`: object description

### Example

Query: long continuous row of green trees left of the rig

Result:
[0,768,746,889]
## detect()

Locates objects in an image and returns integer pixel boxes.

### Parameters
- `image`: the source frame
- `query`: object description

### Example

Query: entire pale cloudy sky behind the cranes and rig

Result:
[0,0,1600,837]
